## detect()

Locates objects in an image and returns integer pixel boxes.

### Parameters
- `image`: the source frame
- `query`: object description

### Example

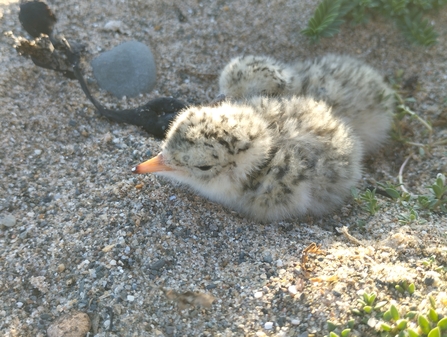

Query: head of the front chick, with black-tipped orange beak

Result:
[133,103,271,195]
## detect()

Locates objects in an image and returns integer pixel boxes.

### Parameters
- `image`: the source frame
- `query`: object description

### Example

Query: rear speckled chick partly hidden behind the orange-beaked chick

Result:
[219,54,394,153]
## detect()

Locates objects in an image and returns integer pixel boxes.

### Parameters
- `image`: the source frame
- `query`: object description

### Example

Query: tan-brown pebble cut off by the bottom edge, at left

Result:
[47,311,92,337]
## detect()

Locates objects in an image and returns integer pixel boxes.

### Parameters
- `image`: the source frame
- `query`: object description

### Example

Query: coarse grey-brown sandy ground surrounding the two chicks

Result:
[0,0,447,337]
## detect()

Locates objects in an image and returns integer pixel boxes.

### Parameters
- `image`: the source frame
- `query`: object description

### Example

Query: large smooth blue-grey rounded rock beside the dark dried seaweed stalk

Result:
[92,41,156,98]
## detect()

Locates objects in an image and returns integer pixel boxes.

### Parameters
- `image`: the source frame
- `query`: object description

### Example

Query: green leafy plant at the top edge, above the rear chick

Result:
[301,0,447,46]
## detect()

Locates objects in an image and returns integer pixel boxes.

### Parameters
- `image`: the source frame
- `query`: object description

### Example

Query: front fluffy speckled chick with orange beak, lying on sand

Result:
[134,96,362,221]
